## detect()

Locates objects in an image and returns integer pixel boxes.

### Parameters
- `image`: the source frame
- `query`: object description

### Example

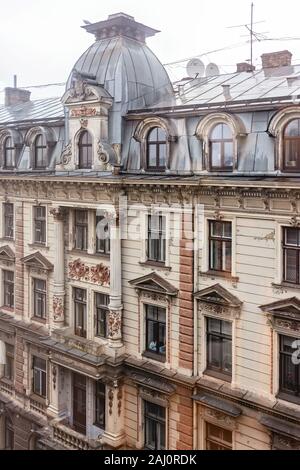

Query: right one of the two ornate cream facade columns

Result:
[108,211,123,348]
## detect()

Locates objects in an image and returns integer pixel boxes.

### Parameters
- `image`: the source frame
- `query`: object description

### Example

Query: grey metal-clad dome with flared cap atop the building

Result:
[67,13,174,114]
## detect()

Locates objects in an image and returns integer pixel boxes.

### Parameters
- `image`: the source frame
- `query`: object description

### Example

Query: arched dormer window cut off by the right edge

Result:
[283,119,300,171]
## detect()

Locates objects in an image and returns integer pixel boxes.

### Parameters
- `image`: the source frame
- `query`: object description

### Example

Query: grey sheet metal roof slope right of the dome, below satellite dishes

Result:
[177,65,300,105]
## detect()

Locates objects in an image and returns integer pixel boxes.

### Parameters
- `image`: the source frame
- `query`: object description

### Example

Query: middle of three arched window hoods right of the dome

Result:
[195,113,247,140]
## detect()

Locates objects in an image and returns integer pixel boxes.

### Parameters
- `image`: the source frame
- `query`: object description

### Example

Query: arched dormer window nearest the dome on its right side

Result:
[147,127,167,170]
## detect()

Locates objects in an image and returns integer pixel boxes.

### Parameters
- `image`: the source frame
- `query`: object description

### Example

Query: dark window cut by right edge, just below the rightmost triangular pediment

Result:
[279,335,300,397]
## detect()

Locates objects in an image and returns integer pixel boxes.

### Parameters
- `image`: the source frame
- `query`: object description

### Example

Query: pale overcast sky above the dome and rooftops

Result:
[0,0,300,98]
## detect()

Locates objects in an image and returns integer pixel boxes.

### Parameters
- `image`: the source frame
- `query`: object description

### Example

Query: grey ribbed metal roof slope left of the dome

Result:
[0,98,64,125]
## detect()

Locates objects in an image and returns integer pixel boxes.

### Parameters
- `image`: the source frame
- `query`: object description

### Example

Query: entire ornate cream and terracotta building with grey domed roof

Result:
[0,14,300,450]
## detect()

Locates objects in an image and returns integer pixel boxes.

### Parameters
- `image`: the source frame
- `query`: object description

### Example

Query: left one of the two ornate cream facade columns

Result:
[50,207,66,328]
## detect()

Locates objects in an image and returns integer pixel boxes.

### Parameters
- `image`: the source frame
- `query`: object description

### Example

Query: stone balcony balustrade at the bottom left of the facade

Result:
[52,423,102,450]
